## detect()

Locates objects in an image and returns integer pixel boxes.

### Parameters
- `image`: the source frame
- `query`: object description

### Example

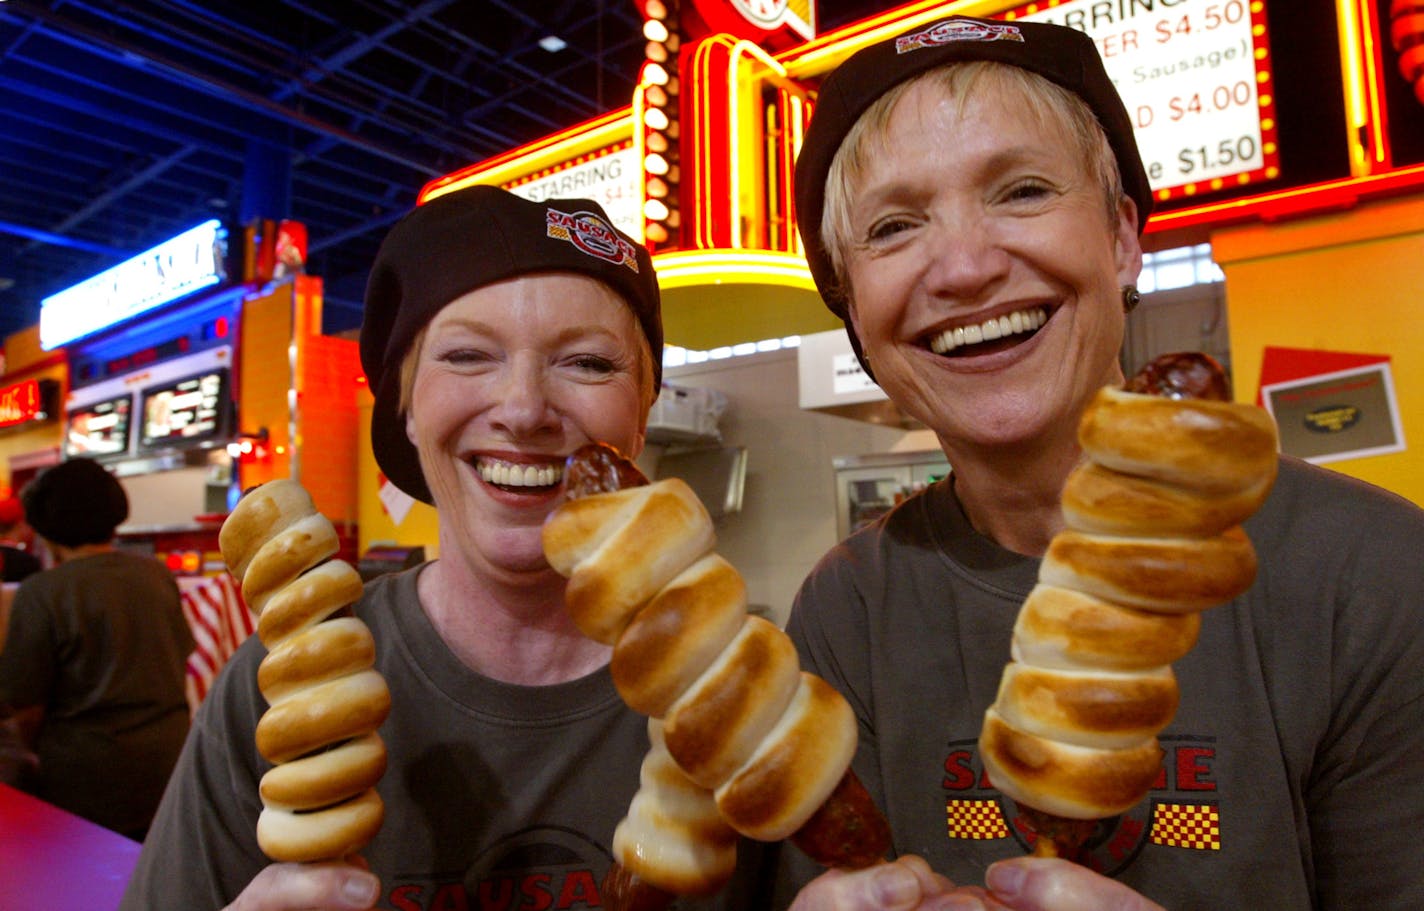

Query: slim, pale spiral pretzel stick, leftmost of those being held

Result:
[218,480,390,863]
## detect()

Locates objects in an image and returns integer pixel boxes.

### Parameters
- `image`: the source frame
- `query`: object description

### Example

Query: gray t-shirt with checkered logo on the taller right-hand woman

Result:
[782,458,1424,911]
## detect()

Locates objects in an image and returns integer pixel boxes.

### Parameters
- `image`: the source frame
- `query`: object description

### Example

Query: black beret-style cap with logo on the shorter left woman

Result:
[360,186,662,502]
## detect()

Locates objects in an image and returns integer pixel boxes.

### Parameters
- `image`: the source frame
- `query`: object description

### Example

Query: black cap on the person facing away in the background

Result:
[20,458,128,547]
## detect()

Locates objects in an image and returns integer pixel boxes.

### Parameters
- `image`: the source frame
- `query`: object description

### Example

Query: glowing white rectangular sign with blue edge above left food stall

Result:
[40,219,228,350]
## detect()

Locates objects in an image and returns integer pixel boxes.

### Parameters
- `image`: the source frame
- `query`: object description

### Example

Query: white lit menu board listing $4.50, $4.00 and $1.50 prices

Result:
[1005,0,1280,201]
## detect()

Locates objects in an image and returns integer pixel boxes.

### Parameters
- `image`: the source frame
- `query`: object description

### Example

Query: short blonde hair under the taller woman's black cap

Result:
[820,60,1124,300]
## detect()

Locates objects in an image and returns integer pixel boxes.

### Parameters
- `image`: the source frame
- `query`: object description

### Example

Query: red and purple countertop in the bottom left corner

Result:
[0,784,140,911]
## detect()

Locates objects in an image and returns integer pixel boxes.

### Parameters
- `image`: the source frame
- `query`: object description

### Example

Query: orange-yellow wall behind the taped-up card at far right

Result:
[1212,198,1424,505]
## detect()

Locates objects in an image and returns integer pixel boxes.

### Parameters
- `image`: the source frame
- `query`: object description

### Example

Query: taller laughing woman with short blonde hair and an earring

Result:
[786,17,1424,911]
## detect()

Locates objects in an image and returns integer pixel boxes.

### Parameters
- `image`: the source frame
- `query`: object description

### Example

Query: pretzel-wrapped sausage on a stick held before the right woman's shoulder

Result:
[980,354,1276,857]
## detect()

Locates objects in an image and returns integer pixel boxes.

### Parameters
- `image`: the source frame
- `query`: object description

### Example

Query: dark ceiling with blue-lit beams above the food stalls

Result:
[0,0,897,347]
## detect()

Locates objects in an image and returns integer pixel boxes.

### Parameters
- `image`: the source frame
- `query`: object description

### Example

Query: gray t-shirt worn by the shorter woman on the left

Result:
[121,568,723,911]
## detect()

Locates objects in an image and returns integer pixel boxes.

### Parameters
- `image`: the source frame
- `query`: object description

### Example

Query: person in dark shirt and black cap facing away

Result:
[0,458,194,840]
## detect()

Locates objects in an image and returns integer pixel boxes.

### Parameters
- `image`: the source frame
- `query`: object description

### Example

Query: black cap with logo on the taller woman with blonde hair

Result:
[796,16,1152,334]
